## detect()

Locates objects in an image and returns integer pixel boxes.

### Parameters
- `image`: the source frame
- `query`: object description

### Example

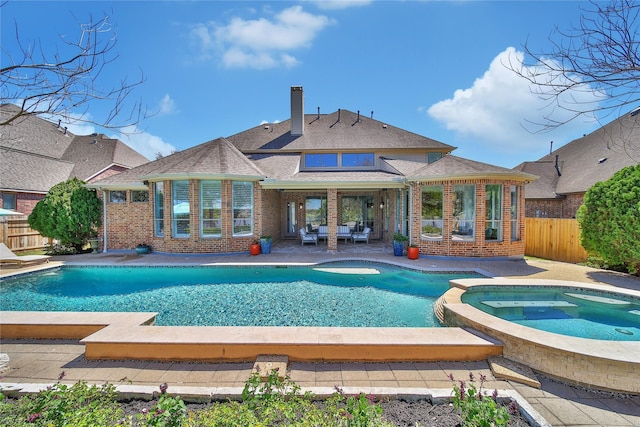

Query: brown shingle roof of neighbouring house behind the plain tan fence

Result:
[514,109,640,199]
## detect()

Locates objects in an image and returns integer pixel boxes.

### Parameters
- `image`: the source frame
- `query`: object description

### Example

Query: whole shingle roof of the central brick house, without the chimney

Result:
[89,99,536,190]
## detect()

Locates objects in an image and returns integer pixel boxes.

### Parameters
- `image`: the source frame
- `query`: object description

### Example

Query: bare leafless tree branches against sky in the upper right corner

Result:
[507,0,640,131]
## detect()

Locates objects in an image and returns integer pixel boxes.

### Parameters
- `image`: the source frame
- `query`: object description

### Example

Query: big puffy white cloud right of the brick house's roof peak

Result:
[427,47,601,153]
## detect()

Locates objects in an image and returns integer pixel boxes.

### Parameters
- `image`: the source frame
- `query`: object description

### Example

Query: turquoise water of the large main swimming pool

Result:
[0,262,482,327]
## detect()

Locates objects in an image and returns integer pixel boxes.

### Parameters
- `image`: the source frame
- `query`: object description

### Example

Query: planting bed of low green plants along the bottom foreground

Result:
[0,370,529,427]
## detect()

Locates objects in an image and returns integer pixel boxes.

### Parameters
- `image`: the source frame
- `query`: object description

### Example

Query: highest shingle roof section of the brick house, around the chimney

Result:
[227,110,455,153]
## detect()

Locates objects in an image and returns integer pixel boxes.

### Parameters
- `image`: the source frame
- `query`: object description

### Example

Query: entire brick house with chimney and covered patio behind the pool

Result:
[88,86,536,257]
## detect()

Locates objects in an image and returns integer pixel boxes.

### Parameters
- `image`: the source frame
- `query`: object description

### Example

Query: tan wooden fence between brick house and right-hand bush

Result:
[524,218,587,263]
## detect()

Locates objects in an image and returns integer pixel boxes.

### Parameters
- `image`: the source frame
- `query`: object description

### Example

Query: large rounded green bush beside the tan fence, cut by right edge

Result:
[577,164,640,274]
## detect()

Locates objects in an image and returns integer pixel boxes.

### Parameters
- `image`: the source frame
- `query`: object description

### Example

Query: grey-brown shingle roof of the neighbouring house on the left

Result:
[0,104,149,193]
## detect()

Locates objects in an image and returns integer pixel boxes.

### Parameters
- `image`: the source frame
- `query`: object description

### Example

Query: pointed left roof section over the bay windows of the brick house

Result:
[88,138,266,190]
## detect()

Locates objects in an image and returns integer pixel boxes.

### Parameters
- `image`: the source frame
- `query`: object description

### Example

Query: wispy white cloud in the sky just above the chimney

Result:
[191,6,333,69]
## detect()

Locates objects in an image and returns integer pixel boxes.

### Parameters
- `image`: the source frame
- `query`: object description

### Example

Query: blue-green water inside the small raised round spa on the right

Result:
[462,286,640,341]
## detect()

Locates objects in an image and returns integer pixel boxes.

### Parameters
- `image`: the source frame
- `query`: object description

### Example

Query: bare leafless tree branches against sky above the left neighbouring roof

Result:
[0,12,145,130]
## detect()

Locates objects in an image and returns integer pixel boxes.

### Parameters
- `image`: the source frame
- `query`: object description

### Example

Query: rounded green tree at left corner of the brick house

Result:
[28,178,101,250]
